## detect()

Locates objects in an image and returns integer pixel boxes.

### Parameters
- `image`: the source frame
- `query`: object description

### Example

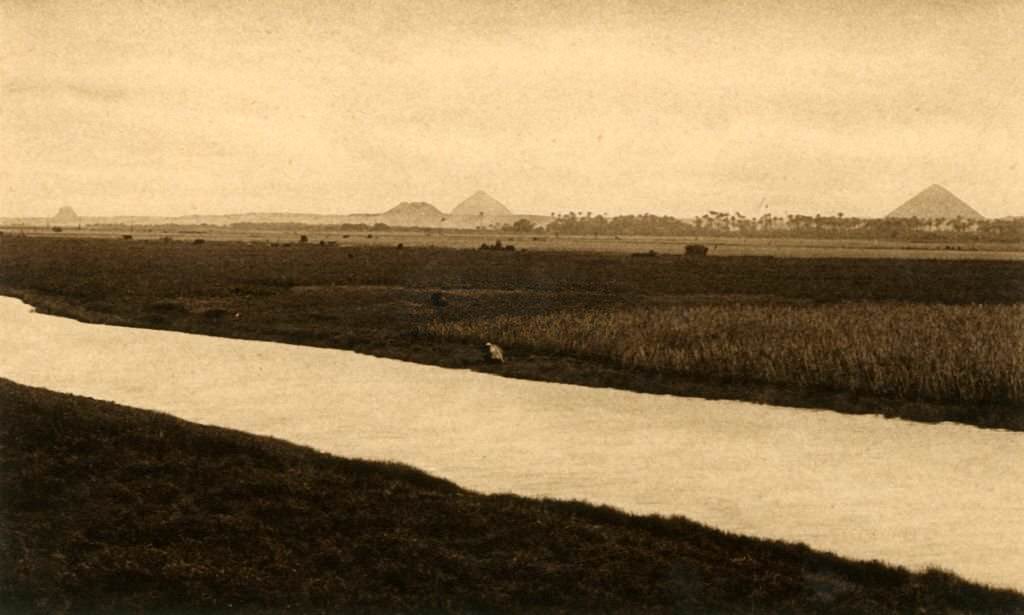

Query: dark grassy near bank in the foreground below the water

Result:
[0,380,1024,613]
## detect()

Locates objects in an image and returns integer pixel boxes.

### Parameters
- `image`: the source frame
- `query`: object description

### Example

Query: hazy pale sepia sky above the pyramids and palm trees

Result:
[0,0,1024,217]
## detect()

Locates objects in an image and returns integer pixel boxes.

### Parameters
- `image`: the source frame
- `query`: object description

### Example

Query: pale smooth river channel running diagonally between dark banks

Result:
[0,298,1024,590]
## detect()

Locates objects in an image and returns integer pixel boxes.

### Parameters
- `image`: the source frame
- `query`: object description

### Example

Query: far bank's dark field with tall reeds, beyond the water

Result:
[0,232,1024,430]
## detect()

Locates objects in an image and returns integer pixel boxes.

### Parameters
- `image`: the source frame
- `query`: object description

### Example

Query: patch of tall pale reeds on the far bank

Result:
[424,303,1024,402]
